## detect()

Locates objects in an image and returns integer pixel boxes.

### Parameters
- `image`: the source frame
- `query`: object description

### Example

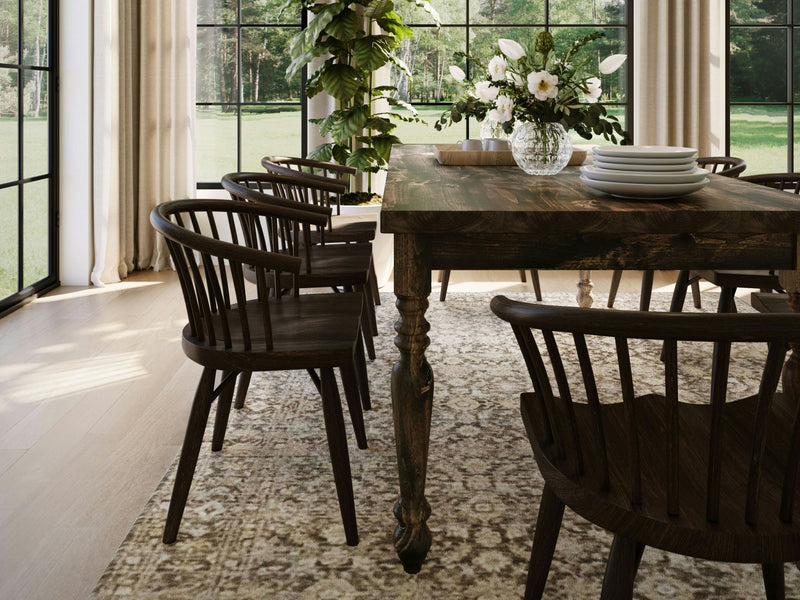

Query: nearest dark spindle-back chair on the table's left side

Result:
[150,200,367,545]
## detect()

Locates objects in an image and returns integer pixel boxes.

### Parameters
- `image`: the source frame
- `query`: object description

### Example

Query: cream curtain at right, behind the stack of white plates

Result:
[633,0,727,156]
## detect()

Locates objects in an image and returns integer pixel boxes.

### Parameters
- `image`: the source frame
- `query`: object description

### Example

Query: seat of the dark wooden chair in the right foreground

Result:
[522,394,800,563]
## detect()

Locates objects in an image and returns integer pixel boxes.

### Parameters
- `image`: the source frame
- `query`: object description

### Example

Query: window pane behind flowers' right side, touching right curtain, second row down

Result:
[553,27,628,102]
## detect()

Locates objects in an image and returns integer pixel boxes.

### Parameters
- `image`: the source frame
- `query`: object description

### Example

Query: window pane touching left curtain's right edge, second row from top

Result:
[197,27,238,102]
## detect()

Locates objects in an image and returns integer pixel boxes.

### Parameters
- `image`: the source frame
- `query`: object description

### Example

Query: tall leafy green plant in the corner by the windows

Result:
[283,0,439,185]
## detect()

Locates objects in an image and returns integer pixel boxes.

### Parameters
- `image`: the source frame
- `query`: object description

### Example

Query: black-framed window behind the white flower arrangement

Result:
[393,0,633,143]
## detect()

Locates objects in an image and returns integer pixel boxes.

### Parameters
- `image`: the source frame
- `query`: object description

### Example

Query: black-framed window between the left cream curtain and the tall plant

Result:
[197,0,307,188]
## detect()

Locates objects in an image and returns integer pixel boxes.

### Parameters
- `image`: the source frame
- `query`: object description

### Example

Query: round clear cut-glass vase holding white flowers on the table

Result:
[511,121,572,175]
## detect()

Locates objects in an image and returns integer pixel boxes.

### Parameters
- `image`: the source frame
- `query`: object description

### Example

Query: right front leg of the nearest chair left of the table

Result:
[321,367,358,546]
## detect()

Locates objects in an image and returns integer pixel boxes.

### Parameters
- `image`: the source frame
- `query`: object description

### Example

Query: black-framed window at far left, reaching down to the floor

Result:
[0,0,58,313]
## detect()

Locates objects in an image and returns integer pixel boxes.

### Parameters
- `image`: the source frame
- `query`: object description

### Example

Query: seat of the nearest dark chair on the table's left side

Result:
[183,293,363,371]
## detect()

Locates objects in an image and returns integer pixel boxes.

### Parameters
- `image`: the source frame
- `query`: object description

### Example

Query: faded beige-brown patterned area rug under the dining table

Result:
[92,293,800,600]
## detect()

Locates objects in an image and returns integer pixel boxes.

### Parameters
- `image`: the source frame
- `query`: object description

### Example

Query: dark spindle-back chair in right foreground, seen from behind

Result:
[491,296,800,600]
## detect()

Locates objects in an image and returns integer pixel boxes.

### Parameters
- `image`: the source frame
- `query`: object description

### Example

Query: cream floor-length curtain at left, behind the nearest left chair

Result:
[91,0,196,285]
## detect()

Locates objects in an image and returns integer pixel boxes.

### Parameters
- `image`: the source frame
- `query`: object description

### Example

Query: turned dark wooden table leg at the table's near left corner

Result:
[392,234,433,573]
